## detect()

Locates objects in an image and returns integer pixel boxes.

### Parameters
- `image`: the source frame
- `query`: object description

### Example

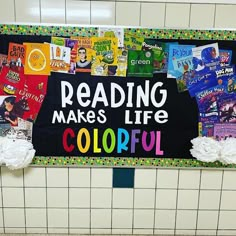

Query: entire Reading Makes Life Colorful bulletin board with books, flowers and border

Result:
[0,25,236,169]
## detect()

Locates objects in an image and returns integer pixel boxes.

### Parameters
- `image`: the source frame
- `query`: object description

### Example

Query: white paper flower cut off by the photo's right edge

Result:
[220,138,236,164]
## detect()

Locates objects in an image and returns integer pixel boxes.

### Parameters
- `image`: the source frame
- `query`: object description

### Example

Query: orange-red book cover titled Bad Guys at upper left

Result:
[8,42,26,68]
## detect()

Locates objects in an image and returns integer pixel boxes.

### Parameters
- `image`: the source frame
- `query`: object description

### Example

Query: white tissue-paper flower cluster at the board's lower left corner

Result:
[0,137,35,170]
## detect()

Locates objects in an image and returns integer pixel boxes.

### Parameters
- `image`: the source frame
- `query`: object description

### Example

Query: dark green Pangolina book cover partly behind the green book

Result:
[142,39,177,73]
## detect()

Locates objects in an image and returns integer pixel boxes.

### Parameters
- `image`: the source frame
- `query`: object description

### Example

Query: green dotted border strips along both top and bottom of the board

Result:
[0,24,236,168]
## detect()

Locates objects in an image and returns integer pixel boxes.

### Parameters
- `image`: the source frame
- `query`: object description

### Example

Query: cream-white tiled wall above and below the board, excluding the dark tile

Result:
[0,0,236,235]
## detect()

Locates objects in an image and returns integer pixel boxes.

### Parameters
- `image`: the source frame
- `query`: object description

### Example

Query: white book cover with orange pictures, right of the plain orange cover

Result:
[49,44,71,73]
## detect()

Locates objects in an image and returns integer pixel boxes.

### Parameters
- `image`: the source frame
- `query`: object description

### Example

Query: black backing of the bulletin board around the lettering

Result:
[0,35,235,158]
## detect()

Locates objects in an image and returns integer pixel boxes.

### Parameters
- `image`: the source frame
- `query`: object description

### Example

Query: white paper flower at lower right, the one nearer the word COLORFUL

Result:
[190,137,221,162]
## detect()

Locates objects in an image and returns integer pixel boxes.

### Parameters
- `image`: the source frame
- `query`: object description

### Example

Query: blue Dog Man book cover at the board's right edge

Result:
[214,65,236,93]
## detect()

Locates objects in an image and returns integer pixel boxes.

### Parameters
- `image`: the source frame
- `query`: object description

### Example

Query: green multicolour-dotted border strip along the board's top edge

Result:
[0,24,236,40]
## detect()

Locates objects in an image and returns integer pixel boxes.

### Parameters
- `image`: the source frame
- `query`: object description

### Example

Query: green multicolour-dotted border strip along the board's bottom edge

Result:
[31,156,236,168]
